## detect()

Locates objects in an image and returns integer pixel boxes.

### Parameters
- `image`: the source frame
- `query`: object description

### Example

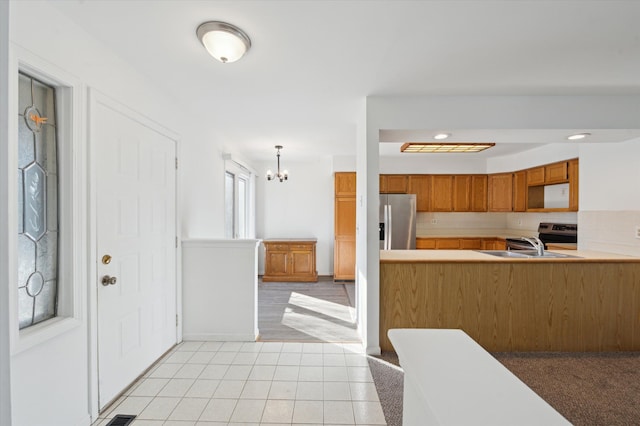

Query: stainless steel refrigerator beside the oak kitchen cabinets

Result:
[379,194,416,250]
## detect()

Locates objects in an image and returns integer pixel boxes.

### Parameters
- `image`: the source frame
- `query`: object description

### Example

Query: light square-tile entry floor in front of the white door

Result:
[94,342,385,426]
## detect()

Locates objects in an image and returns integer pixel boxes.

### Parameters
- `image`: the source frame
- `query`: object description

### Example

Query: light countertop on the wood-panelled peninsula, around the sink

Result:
[380,250,640,263]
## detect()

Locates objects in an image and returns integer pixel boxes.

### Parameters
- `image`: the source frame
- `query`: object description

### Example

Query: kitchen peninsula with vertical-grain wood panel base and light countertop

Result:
[380,250,640,352]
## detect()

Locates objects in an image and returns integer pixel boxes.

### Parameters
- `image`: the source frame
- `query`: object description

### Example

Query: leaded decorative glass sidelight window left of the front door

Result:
[18,73,58,329]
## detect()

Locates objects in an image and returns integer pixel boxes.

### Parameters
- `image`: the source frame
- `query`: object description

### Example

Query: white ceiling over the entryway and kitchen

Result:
[52,0,640,160]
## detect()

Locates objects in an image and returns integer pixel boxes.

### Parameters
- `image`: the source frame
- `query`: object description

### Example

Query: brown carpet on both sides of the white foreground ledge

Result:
[369,352,640,426]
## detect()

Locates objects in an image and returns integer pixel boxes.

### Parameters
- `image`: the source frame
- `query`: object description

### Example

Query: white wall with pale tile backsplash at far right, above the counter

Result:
[578,139,640,256]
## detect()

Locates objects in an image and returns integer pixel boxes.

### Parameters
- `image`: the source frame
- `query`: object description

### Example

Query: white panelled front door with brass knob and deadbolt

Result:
[91,102,176,409]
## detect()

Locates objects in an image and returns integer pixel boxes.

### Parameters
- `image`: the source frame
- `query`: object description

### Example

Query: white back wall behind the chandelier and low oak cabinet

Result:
[256,158,334,275]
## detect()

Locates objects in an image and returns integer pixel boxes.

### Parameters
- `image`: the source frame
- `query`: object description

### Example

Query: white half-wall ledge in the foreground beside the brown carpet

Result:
[389,329,570,426]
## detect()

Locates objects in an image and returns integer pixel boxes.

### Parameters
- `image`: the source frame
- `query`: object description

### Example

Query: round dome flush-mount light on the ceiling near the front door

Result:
[196,21,251,63]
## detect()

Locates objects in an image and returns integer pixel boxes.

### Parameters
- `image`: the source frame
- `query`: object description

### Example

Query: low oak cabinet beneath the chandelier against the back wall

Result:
[262,238,318,282]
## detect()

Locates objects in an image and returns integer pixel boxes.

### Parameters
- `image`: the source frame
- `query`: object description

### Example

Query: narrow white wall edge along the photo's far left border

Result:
[0,2,13,425]
